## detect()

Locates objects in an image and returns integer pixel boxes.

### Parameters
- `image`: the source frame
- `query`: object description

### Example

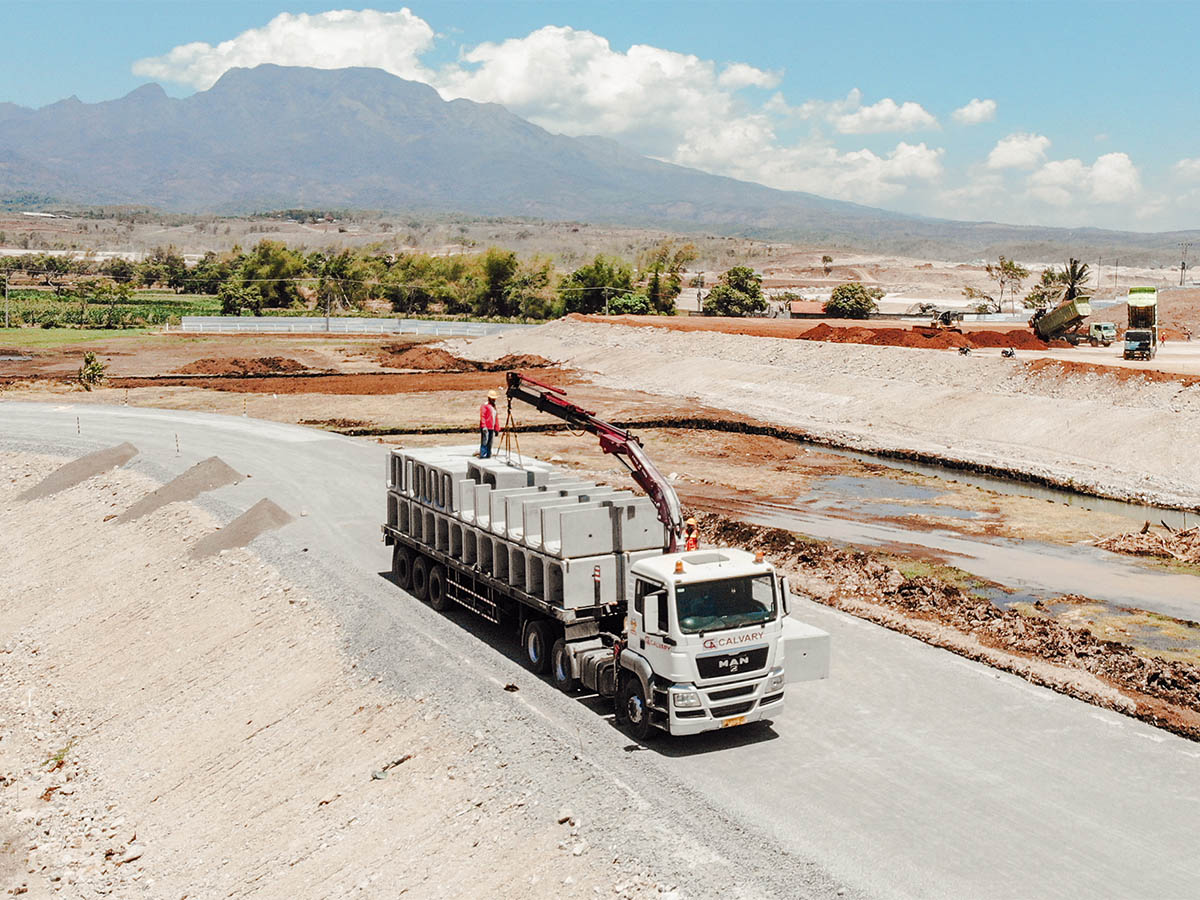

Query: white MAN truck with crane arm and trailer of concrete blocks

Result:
[383,372,829,739]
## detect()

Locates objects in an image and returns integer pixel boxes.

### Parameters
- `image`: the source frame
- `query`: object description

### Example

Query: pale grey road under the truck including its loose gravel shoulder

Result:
[0,402,1200,898]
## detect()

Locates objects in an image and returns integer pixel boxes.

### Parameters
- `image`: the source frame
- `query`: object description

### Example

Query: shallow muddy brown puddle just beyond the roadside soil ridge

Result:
[727,489,1200,619]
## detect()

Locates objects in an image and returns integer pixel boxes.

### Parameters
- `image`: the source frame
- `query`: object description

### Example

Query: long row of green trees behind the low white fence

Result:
[0,240,715,319]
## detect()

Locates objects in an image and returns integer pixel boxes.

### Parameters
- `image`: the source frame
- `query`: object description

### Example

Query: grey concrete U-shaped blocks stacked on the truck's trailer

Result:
[388,445,665,607]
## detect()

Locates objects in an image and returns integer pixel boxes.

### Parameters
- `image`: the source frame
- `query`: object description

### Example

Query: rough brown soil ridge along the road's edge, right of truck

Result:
[700,512,1200,740]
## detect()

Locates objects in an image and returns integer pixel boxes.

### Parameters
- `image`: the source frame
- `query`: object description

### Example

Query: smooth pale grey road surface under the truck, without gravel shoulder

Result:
[0,401,1200,898]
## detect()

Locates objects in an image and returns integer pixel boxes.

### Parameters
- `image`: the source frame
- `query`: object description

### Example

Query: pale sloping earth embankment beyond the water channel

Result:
[451,320,1200,509]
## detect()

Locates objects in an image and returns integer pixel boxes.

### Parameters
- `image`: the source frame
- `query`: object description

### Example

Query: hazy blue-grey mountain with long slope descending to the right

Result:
[0,65,1196,262]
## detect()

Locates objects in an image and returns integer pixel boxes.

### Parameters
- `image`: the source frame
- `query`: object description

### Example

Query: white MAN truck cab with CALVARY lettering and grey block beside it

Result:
[616,548,829,734]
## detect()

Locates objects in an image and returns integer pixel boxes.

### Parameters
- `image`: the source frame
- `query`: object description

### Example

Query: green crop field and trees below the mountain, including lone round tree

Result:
[0,237,748,329]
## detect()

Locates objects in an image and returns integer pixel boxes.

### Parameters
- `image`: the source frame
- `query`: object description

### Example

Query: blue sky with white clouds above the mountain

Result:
[0,0,1200,230]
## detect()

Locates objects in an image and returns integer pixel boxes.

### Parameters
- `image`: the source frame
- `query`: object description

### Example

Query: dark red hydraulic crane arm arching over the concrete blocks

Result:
[506,372,683,553]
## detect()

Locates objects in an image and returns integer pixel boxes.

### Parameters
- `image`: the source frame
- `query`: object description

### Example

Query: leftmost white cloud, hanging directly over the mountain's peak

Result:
[133,10,433,90]
